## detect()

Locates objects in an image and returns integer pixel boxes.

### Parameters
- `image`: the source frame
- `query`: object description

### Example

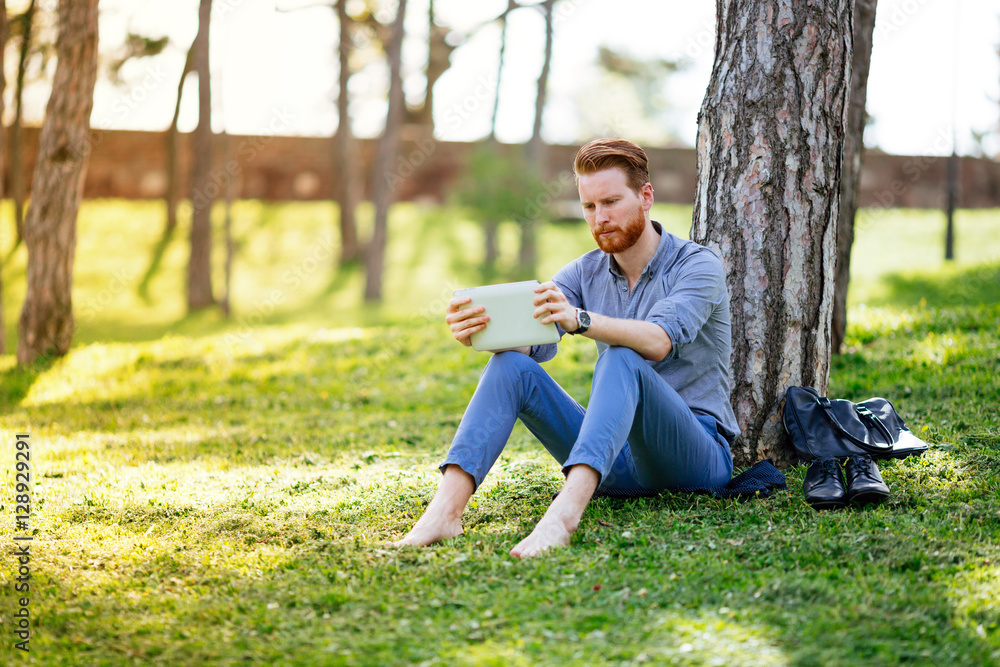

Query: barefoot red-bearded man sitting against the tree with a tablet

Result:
[395,139,739,558]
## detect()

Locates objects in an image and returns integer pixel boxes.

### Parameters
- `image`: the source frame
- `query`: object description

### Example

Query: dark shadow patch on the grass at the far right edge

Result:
[872,264,1000,308]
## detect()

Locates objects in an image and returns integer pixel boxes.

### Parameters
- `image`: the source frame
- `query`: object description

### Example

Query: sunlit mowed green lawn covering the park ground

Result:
[0,201,1000,666]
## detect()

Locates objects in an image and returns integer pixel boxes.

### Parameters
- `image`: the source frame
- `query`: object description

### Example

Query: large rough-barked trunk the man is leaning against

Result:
[691,0,853,465]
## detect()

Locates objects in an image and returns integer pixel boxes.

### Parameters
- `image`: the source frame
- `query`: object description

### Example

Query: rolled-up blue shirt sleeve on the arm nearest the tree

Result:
[646,248,728,359]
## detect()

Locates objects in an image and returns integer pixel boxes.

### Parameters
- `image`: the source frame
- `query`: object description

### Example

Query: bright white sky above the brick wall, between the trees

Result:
[27,0,1000,155]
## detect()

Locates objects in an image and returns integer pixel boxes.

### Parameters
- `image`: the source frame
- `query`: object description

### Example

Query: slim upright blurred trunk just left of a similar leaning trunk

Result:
[334,0,361,264]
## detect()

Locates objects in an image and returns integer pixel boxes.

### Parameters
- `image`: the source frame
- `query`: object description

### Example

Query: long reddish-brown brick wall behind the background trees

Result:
[5,128,1000,208]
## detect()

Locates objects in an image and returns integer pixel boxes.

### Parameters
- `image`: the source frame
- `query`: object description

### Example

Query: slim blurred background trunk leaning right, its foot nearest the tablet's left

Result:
[365,0,406,302]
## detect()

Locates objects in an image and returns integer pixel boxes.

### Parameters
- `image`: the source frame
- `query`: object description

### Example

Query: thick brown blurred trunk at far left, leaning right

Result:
[17,0,97,364]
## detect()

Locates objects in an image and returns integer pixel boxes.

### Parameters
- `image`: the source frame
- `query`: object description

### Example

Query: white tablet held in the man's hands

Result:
[455,280,559,350]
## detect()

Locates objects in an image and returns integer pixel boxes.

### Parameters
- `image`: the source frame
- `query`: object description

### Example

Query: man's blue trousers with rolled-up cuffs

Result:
[441,347,733,490]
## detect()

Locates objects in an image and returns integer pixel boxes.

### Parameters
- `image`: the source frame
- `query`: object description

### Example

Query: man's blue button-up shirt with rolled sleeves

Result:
[531,221,740,444]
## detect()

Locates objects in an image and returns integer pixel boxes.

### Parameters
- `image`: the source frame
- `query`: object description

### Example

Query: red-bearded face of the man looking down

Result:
[579,167,653,254]
